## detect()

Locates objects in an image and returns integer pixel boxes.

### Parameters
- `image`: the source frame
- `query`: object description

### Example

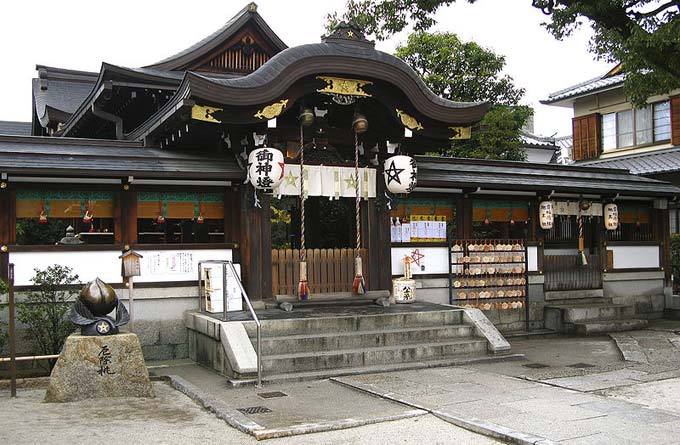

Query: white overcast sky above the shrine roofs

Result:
[0,0,610,136]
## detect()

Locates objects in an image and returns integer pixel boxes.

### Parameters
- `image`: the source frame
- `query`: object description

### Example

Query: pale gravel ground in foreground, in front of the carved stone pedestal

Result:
[0,382,498,445]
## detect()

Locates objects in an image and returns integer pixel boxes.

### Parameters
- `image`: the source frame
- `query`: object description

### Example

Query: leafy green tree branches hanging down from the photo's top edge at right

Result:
[328,0,680,105]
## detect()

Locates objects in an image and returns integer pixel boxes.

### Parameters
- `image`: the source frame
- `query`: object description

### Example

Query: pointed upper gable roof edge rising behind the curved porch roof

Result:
[144,3,288,70]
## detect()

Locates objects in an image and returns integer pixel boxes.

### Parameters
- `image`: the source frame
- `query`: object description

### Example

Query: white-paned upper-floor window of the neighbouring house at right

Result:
[602,101,671,151]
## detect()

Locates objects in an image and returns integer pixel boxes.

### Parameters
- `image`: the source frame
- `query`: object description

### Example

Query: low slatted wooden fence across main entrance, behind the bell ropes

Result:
[272,249,369,295]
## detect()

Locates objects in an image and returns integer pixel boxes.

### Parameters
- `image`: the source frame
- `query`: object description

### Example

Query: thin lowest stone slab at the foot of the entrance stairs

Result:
[229,354,526,386]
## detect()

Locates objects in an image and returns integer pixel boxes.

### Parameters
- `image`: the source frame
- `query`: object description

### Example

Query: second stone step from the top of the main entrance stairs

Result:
[251,324,472,355]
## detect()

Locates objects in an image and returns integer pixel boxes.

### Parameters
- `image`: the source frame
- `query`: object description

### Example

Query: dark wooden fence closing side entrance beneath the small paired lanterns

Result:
[543,254,602,291]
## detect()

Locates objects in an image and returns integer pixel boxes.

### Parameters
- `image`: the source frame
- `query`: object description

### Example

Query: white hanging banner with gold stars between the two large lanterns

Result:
[273,164,376,199]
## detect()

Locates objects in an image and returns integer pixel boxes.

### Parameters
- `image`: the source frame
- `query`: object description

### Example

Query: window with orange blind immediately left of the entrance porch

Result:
[137,192,224,244]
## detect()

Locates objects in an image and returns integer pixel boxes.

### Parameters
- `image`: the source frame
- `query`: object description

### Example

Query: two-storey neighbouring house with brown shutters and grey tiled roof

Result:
[541,65,680,233]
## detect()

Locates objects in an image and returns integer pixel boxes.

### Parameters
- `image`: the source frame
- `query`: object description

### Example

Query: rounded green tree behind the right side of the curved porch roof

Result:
[396,31,532,161]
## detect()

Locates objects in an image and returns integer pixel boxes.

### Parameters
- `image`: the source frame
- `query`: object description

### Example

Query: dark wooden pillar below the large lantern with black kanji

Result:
[239,187,272,300]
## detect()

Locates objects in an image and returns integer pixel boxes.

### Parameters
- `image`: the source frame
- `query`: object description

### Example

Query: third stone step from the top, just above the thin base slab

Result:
[262,339,487,373]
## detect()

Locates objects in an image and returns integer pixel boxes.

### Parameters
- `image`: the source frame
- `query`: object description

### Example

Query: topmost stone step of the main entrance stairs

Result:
[245,309,463,337]
